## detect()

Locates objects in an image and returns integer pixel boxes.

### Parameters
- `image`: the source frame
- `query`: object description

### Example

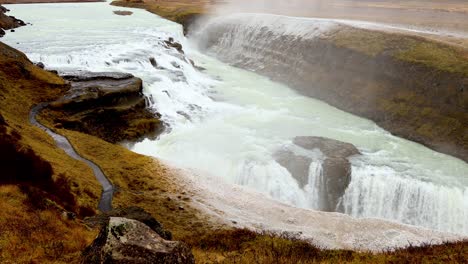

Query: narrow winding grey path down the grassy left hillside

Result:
[29,103,115,212]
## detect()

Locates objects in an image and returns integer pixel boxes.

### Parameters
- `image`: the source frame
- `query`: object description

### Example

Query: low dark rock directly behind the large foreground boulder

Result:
[85,206,172,240]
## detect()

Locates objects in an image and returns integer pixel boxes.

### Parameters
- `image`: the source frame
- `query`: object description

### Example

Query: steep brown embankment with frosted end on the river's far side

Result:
[197,14,468,161]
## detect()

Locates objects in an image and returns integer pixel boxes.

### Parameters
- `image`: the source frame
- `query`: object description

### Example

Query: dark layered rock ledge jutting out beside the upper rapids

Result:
[46,72,164,143]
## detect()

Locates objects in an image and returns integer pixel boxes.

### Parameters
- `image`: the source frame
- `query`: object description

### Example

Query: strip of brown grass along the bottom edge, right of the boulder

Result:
[185,229,468,263]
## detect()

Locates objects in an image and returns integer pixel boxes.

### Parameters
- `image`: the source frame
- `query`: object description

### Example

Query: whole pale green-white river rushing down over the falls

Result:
[2,3,468,234]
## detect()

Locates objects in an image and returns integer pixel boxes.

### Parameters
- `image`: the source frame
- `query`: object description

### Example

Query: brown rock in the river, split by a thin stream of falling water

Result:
[275,137,360,212]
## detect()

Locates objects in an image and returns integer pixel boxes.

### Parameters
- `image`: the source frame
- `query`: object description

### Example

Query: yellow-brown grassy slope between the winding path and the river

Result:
[60,130,225,239]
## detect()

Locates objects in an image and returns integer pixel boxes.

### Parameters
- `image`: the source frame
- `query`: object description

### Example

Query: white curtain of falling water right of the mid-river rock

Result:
[342,166,468,234]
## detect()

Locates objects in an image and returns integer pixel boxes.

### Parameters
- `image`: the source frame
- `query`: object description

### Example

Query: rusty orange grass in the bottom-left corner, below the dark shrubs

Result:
[0,185,96,263]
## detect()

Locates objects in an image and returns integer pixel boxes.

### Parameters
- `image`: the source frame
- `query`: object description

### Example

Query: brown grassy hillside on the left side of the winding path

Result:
[0,43,100,263]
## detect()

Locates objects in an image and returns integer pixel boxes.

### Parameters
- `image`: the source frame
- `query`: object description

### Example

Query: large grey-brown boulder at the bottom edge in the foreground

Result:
[83,217,195,264]
